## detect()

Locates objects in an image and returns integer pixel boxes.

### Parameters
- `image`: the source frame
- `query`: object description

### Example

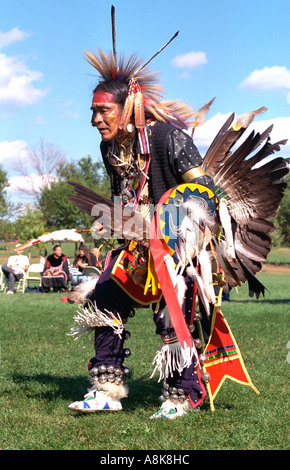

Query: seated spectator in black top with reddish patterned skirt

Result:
[41,245,69,292]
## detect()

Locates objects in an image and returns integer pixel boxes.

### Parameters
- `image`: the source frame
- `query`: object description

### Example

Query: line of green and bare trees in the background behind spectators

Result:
[0,140,290,247]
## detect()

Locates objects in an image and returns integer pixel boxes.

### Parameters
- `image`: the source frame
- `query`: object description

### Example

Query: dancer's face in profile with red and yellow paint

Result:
[91,91,123,142]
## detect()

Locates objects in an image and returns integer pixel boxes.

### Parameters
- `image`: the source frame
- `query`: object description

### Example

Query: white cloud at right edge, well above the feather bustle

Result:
[239,66,290,91]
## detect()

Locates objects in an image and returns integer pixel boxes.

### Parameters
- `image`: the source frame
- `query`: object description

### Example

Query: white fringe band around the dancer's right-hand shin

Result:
[150,339,197,382]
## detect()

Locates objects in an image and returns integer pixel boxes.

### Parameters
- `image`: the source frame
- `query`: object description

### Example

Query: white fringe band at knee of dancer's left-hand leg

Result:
[68,302,124,340]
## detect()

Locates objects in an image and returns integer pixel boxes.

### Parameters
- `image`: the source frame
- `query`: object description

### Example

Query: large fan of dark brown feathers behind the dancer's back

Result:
[203,107,289,296]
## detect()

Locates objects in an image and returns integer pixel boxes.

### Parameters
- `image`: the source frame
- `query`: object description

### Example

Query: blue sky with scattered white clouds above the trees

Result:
[0,0,290,202]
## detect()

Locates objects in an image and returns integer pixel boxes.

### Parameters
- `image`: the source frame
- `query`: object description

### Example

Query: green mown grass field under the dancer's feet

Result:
[0,274,290,451]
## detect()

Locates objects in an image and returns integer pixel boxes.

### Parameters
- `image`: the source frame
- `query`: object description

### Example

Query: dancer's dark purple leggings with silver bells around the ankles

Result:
[88,253,210,406]
